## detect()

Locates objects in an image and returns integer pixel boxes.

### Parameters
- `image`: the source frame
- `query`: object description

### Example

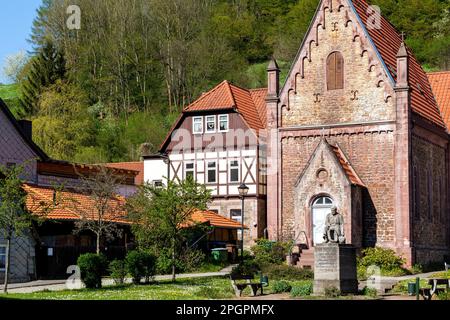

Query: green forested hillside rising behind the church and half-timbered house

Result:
[0,0,450,163]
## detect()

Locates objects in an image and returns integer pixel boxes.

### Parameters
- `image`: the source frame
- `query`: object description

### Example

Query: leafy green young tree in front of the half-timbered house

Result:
[128,179,211,281]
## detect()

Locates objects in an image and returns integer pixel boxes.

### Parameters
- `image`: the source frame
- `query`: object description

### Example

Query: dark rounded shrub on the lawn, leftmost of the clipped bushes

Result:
[77,253,108,289]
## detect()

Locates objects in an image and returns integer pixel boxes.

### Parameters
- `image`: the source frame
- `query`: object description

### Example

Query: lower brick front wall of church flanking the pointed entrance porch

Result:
[282,132,395,245]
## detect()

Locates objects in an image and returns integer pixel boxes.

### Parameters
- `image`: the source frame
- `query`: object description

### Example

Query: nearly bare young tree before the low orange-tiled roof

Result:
[68,166,126,254]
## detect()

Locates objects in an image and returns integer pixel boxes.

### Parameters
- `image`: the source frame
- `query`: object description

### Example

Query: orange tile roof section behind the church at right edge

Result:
[428,71,450,129]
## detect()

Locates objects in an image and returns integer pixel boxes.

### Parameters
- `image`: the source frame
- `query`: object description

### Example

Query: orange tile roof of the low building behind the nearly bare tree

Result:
[23,184,129,224]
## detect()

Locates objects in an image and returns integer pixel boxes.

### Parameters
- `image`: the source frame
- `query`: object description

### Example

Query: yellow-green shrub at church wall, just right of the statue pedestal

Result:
[358,247,405,271]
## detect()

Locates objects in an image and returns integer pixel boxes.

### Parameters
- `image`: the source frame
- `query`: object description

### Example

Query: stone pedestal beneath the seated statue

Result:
[313,243,358,295]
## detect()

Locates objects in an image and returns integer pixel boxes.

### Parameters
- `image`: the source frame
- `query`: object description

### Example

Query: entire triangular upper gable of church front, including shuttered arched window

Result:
[279,0,395,127]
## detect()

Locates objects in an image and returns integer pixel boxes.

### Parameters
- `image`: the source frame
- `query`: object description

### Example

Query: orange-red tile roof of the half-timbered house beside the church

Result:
[183,80,267,131]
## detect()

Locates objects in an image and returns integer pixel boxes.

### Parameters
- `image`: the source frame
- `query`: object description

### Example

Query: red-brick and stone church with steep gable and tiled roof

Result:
[266,0,450,265]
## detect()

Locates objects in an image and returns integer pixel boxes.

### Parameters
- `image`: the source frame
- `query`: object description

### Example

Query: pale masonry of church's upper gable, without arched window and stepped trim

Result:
[282,4,395,127]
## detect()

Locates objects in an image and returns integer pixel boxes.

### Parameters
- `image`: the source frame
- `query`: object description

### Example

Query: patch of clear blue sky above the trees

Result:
[0,0,41,83]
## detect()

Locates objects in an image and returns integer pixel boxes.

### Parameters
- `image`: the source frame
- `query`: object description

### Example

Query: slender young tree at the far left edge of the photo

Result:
[0,165,56,293]
